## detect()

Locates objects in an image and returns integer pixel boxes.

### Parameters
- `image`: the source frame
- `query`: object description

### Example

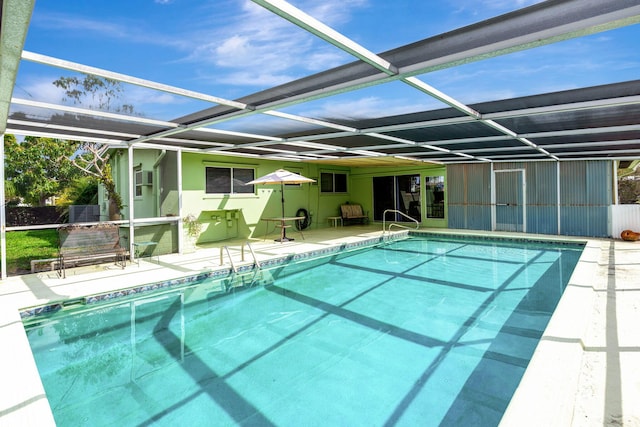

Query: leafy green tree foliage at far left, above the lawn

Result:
[5,135,80,206]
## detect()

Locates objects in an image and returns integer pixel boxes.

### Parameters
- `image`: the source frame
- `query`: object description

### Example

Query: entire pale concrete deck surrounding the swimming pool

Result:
[0,224,640,426]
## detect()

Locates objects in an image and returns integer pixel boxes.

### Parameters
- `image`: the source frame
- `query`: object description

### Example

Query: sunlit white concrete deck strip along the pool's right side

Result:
[501,240,640,427]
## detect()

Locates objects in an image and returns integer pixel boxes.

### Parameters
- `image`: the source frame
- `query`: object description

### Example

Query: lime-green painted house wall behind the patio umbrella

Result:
[118,149,446,244]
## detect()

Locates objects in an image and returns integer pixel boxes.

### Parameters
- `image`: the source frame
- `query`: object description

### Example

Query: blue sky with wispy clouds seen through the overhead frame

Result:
[14,0,640,131]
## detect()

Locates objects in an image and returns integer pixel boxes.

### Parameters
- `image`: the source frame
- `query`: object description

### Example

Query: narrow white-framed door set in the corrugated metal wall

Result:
[493,169,527,232]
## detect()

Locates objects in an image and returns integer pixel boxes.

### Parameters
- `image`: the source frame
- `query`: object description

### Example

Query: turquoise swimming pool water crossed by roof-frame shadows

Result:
[25,238,582,426]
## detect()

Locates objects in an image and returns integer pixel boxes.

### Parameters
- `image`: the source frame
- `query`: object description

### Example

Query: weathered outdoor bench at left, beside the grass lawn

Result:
[57,224,127,278]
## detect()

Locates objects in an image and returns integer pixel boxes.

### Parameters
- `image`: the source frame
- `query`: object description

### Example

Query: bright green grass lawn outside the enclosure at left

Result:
[7,229,58,275]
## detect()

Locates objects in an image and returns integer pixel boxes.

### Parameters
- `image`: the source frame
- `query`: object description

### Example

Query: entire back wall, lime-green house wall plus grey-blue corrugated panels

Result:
[107,149,613,246]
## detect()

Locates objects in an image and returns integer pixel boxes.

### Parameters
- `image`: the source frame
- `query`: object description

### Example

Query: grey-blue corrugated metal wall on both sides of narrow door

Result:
[447,161,613,237]
